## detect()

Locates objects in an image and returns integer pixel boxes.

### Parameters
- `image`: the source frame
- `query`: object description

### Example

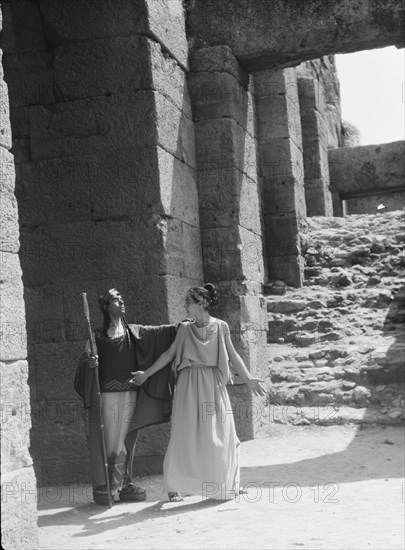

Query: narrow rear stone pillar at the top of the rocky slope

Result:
[298,78,333,216]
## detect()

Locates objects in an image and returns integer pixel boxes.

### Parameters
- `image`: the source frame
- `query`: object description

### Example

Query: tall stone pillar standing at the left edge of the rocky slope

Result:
[254,69,306,287]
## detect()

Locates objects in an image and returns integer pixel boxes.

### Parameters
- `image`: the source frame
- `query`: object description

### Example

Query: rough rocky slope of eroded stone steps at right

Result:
[266,211,405,424]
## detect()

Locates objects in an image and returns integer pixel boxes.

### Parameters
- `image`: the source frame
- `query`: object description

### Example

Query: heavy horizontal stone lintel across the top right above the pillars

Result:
[187,0,404,71]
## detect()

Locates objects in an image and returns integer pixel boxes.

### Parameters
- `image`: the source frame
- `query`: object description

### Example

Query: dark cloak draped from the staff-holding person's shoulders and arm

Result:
[74,325,178,486]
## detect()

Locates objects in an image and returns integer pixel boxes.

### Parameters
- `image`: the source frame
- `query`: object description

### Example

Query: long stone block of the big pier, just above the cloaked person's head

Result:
[21,218,199,286]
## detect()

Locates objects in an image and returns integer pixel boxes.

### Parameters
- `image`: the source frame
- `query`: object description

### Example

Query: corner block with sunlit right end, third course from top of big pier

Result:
[30,90,195,167]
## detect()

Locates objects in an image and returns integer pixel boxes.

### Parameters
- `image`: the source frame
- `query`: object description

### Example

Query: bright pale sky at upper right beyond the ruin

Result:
[335,47,405,145]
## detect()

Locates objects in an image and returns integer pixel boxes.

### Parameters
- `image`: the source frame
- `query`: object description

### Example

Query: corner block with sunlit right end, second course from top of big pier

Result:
[53,36,191,118]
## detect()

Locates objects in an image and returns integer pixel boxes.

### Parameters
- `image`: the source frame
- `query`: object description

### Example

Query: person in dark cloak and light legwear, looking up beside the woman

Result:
[75,288,176,504]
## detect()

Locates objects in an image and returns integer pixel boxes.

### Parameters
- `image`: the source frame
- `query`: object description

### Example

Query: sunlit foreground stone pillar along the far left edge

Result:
[0,5,38,549]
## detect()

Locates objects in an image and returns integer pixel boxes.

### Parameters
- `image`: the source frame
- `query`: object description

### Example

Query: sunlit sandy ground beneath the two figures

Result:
[38,424,405,550]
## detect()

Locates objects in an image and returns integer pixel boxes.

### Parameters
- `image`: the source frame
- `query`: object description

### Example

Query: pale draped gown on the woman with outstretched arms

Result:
[163,321,240,500]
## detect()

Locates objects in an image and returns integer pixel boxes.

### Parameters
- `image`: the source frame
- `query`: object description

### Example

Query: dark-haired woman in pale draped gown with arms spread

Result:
[132,284,265,500]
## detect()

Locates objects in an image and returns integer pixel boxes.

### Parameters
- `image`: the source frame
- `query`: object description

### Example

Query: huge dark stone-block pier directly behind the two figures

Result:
[1,0,203,484]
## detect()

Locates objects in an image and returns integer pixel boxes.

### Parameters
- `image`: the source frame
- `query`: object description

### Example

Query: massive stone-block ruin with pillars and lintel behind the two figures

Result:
[0,0,401,548]
